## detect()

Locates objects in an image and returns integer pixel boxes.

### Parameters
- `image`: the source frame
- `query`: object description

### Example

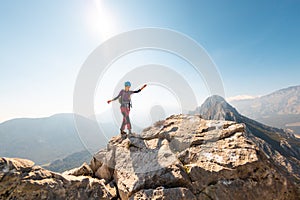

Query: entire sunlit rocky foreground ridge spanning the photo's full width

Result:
[0,115,300,200]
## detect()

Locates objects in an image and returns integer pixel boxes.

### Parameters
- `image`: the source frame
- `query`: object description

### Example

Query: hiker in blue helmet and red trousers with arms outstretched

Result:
[107,81,147,135]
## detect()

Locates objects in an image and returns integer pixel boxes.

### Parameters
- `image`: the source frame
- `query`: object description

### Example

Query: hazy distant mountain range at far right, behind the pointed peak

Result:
[230,86,300,134]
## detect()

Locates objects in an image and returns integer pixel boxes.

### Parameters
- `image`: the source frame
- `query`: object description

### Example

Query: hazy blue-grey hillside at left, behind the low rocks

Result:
[0,114,106,165]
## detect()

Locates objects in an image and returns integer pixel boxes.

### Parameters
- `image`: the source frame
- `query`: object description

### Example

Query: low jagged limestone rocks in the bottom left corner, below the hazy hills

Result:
[0,158,117,200]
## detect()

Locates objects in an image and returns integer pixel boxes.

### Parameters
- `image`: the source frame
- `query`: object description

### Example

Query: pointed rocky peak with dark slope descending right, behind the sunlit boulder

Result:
[194,95,300,178]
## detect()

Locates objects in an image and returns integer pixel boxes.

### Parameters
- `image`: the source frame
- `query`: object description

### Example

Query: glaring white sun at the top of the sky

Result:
[86,0,117,41]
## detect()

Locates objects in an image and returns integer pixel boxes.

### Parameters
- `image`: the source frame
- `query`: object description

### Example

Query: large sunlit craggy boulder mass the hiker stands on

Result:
[91,115,299,200]
